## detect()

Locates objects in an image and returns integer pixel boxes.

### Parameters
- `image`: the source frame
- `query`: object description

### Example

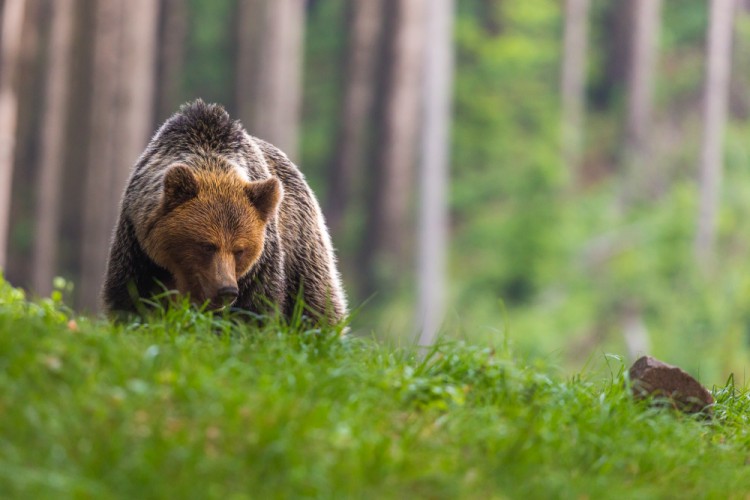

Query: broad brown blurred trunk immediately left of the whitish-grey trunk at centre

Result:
[361,0,427,296]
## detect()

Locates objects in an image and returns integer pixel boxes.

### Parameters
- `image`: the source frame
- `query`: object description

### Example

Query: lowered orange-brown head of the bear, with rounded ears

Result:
[143,165,283,310]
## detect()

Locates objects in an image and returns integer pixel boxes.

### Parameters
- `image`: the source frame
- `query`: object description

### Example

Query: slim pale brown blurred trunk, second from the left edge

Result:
[32,0,75,296]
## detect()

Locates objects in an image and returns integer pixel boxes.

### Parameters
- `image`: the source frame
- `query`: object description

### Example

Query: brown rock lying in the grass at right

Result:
[629,356,714,413]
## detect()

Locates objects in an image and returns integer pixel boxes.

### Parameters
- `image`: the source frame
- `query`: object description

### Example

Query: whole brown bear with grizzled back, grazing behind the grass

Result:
[103,100,347,323]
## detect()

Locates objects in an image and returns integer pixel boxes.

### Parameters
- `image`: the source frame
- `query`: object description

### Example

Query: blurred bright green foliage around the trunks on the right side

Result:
[434,0,750,382]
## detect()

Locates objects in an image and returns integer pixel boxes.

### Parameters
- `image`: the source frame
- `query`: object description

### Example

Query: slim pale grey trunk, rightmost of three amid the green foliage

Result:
[695,0,735,269]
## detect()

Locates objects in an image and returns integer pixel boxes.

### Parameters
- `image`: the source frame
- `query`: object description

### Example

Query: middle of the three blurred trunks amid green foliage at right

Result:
[624,0,661,205]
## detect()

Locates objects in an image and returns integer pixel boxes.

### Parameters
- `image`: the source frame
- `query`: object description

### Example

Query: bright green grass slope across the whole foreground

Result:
[0,282,750,499]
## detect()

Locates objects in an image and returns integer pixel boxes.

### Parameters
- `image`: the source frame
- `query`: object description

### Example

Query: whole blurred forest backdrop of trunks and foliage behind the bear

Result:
[0,0,750,384]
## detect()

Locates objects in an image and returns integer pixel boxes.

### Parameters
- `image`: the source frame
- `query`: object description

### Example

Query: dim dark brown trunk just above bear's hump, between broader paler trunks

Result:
[155,0,188,125]
